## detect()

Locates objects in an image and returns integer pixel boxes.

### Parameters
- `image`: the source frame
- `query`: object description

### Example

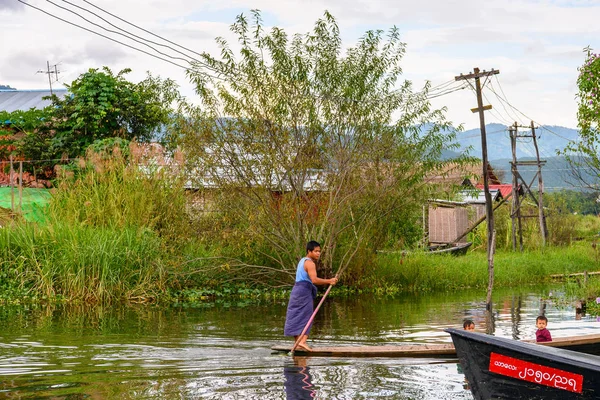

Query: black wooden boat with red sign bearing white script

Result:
[446,329,600,400]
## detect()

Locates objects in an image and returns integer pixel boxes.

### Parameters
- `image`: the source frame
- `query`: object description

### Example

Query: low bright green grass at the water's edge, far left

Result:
[0,223,165,303]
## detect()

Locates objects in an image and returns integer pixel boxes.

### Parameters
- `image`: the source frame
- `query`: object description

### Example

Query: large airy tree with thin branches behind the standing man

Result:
[181,11,460,283]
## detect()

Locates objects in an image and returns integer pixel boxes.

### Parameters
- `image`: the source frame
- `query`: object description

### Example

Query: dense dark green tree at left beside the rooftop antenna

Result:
[21,67,180,159]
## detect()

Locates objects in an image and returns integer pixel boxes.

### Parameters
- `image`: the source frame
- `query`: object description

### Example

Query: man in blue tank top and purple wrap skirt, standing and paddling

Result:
[283,240,338,351]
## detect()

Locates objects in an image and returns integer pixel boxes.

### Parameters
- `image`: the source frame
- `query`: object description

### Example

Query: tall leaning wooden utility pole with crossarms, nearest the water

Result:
[454,67,500,311]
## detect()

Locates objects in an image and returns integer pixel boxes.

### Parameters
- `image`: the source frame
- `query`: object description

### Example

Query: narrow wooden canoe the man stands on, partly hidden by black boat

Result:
[271,334,600,357]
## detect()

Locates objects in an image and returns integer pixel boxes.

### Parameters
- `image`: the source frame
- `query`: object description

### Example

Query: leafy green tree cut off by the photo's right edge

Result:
[560,48,600,191]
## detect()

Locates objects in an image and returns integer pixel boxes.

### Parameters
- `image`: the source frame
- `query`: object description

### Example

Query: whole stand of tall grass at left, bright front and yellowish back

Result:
[0,145,190,302]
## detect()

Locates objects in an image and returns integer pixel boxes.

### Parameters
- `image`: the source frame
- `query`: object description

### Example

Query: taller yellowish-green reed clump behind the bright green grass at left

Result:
[49,143,189,245]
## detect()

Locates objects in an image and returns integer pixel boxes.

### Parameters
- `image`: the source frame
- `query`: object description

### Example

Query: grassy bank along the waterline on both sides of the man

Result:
[0,148,600,303]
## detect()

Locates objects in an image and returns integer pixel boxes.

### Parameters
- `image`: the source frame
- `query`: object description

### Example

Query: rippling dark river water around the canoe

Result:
[0,288,600,399]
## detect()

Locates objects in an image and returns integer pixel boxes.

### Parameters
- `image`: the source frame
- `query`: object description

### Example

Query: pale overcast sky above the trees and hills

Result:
[0,0,600,129]
